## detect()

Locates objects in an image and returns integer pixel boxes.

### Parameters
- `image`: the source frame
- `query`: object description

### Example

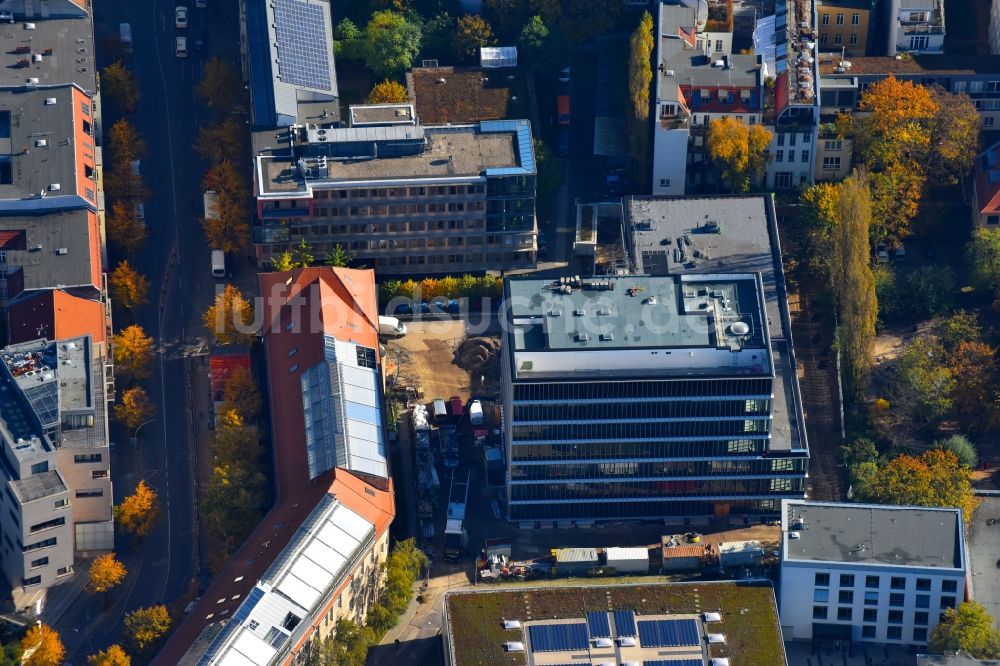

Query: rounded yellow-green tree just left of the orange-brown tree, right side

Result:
[889,337,955,422]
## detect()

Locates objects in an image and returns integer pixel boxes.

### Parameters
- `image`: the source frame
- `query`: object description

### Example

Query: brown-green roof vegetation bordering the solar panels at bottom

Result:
[445,581,785,666]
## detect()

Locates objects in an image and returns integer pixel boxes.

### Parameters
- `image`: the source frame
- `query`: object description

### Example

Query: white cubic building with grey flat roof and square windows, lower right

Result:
[779,500,969,646]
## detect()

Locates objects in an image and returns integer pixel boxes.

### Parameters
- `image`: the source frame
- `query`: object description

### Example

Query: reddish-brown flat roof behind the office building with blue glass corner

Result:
[406,67,529,125]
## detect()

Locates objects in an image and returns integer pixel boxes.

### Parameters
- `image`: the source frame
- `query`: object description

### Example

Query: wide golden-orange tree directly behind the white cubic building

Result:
[854,449,979,522]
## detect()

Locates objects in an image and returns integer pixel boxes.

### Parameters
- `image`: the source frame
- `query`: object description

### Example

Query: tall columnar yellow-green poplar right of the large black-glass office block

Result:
[830,173,878,401]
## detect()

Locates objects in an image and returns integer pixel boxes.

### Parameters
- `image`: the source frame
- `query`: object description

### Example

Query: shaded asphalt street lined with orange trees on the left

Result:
[59,0,248,658]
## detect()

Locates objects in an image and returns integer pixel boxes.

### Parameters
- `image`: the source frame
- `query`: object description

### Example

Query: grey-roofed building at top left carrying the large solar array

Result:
[240,0,340,128]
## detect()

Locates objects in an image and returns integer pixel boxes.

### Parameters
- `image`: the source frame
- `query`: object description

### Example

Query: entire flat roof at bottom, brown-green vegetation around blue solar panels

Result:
[445,580,787,666]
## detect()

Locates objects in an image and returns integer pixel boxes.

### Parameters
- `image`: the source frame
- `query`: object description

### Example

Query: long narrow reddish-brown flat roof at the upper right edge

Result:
[819,53,1000,78]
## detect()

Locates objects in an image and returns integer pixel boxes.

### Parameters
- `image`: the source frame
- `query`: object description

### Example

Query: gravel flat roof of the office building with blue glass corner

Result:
[257,120,535,196]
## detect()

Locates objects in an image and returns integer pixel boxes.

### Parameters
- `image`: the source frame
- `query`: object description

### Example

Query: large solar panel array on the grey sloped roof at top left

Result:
[274,0,333,90]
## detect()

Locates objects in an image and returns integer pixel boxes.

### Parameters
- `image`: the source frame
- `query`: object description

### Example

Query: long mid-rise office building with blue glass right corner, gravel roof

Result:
[254,104,537,275]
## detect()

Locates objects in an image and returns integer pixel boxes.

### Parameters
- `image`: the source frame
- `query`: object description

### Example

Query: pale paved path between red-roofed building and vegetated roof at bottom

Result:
[368,571,471,666]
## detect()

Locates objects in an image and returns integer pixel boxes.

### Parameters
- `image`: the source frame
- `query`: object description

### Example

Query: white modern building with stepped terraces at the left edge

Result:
[0,336,114,607]
